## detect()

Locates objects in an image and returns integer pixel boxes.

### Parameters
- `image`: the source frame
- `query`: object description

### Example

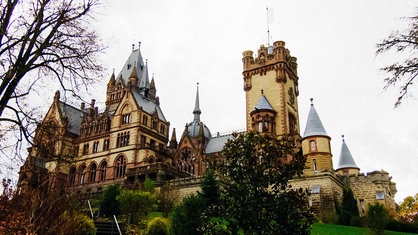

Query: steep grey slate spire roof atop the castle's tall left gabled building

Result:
[116,48,145,84]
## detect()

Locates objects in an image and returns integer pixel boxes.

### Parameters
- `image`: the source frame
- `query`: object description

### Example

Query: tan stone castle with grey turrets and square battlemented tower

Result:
[19,41,396,218]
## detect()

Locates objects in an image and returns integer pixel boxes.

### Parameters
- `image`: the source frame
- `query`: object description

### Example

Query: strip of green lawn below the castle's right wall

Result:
[311,223,414,235]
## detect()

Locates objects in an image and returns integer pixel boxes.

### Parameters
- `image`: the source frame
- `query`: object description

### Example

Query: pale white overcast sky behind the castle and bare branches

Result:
[3,0,418,202]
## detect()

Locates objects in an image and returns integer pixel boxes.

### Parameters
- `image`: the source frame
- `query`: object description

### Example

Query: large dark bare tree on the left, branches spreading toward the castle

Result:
[0,0,104,141]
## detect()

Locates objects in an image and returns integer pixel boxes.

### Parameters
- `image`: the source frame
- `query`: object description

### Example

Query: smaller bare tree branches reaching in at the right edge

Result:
[376,8,418,107]
